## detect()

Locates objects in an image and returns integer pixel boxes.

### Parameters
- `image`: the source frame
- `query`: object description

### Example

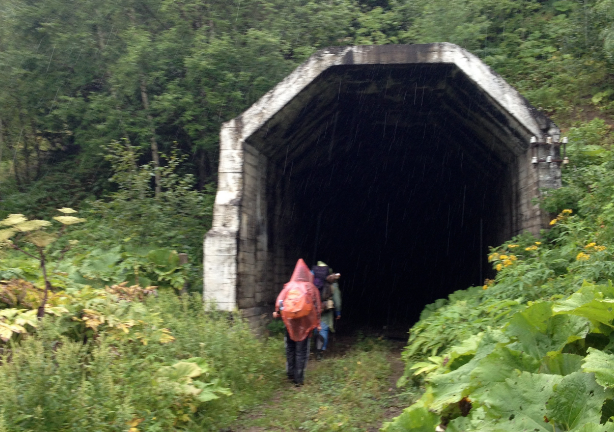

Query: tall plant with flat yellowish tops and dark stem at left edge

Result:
[0,207,85,318]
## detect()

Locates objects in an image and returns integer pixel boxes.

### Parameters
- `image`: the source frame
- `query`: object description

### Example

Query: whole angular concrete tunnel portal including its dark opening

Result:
[204,43,560,325]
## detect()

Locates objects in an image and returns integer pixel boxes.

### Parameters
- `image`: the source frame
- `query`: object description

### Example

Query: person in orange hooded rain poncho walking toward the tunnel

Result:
[273,259,322,386]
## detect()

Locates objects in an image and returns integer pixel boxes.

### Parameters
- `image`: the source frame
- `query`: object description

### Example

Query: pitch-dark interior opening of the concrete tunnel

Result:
[252,65,514,328]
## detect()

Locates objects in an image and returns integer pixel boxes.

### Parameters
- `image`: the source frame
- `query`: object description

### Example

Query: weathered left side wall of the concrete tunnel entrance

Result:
[204,138,296,324]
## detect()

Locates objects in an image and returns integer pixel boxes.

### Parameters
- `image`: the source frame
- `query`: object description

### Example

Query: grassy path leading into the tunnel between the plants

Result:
[227,333,410,432]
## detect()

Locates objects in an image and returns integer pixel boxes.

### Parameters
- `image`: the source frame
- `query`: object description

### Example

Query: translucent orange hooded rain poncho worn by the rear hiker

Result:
[275,259,322,342]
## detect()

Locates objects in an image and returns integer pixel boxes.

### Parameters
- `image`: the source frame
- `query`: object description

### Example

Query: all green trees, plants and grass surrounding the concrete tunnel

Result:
[0,0,614,432]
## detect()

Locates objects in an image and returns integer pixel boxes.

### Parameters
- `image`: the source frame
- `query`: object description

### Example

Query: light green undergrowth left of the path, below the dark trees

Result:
[0,198,283,432]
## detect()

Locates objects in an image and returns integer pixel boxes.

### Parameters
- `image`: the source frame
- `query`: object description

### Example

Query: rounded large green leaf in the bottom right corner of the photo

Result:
[546,372,606,431]
